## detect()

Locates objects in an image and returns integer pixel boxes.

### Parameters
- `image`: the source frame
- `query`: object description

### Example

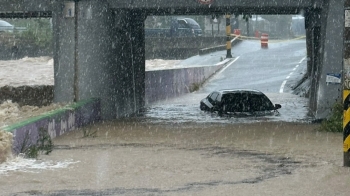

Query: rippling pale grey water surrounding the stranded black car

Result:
[139,92,314,124]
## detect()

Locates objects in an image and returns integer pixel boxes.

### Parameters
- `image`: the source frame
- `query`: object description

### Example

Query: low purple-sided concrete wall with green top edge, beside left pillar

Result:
[2,99,101,154]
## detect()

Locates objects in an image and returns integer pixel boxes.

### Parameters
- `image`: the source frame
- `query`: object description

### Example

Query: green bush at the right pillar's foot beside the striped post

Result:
[320,103,344,132]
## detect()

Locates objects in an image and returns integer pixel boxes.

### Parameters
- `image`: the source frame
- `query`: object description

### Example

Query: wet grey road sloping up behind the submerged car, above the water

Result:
[196,40,306,93]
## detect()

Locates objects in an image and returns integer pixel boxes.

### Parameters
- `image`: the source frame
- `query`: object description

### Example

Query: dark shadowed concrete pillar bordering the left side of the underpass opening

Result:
[115,10,146,117]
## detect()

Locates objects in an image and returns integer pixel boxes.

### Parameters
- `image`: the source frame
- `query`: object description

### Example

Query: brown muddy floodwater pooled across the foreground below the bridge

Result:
[0,119,350,195]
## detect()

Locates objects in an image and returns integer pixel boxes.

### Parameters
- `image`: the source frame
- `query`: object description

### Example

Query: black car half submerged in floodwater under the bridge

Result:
[200,89,281,116]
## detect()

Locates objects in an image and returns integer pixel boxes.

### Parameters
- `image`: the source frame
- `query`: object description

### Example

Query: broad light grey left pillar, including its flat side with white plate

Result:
[53,0,125,119]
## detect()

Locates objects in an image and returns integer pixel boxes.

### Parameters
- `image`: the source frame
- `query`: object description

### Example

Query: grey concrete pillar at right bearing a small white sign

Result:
[316,0,344,119]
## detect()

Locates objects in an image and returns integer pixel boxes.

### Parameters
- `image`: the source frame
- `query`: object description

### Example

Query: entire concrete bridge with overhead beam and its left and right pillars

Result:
[0,0,344,119]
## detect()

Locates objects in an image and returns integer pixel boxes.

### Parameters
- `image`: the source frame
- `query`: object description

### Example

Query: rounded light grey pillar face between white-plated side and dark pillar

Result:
[76,0,118,119]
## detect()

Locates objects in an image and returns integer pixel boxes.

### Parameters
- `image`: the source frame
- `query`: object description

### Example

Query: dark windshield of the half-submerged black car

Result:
[222,92,274,112]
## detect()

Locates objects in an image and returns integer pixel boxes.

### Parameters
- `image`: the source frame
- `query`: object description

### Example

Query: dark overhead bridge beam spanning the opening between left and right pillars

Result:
[108,0,314,15]
